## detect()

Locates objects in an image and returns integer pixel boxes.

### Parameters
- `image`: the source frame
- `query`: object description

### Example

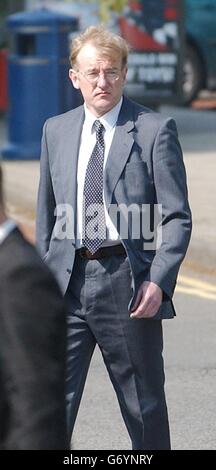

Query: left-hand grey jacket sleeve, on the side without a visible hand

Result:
[36,122,56,258]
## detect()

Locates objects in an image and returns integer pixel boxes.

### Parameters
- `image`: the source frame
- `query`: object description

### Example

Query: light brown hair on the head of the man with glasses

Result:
[69,25,129,68]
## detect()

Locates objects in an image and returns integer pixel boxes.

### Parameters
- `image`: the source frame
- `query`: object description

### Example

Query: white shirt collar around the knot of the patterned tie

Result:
[84,97,123,132]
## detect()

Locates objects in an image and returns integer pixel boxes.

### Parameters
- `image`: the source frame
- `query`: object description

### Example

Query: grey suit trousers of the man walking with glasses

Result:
[65,255,170,450]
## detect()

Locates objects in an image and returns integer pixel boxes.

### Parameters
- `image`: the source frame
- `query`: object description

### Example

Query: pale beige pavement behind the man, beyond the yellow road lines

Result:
[0,106,216,276]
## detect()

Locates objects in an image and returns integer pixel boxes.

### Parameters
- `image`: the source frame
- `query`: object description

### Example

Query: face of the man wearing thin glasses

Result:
[69,44,127,117]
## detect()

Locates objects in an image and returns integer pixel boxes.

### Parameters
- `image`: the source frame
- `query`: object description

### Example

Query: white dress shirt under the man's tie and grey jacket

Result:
[76,98,123,249]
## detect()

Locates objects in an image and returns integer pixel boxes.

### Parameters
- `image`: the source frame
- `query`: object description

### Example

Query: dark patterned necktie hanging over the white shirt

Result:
[83,120,106,254]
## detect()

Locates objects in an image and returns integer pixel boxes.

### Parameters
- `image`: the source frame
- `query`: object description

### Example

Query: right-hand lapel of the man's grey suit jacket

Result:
[104,98,134,207]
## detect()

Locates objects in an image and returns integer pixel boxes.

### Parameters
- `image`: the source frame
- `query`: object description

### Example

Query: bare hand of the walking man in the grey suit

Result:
[130,281,163,318]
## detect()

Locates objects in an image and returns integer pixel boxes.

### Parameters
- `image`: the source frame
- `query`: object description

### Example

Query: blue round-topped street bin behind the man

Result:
[2,8,80,160]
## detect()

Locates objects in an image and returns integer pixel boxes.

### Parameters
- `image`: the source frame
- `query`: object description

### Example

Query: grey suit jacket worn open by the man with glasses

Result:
[36,97,191,318]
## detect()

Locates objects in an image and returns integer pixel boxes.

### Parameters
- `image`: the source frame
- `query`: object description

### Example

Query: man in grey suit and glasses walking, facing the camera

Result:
[37,27,191,449]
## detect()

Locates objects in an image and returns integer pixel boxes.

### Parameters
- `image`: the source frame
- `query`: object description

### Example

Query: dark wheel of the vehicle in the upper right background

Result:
[182,45,203,105]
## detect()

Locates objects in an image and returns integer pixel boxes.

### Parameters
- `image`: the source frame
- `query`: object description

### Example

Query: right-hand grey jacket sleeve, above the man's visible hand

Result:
[150,118,192,297]
